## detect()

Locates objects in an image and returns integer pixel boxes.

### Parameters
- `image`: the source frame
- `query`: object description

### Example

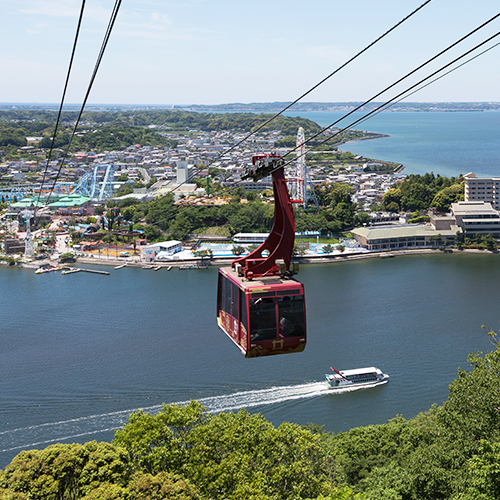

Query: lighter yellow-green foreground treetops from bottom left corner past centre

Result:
[0,401,332,500]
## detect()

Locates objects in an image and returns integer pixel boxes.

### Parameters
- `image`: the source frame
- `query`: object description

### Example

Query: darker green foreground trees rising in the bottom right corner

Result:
[326,334,500,500]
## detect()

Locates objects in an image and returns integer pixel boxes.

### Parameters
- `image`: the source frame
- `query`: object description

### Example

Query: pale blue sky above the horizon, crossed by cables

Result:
[0,0,500,104]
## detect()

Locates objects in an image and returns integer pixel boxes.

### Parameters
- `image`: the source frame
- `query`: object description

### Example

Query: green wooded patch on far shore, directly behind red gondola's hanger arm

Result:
[108,182,369,242]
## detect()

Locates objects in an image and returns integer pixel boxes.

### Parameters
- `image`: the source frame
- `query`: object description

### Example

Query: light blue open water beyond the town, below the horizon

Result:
[286,111,500,177]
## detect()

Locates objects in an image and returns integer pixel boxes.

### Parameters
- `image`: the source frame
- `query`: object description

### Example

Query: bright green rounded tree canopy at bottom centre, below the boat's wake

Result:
[115,401,331,499]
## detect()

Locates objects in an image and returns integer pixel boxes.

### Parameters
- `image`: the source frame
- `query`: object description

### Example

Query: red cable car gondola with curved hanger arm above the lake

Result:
[217,155,306,358]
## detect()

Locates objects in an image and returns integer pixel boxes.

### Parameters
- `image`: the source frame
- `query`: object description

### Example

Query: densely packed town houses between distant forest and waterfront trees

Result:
[0,130,405,208]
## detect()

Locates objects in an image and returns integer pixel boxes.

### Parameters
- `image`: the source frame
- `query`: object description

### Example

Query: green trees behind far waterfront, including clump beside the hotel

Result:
[103,173,471,246]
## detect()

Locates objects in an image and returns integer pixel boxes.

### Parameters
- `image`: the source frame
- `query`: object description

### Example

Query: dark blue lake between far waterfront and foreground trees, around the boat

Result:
[0,254,500,467]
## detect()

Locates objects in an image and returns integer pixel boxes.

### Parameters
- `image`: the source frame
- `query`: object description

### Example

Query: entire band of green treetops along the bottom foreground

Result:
[0,329,500,500]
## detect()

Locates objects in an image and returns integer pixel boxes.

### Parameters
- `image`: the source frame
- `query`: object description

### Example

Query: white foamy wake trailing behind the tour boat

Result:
[0,382,366,453]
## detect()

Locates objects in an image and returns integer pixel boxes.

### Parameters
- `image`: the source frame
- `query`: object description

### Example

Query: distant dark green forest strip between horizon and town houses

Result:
[0,110,320,151]
